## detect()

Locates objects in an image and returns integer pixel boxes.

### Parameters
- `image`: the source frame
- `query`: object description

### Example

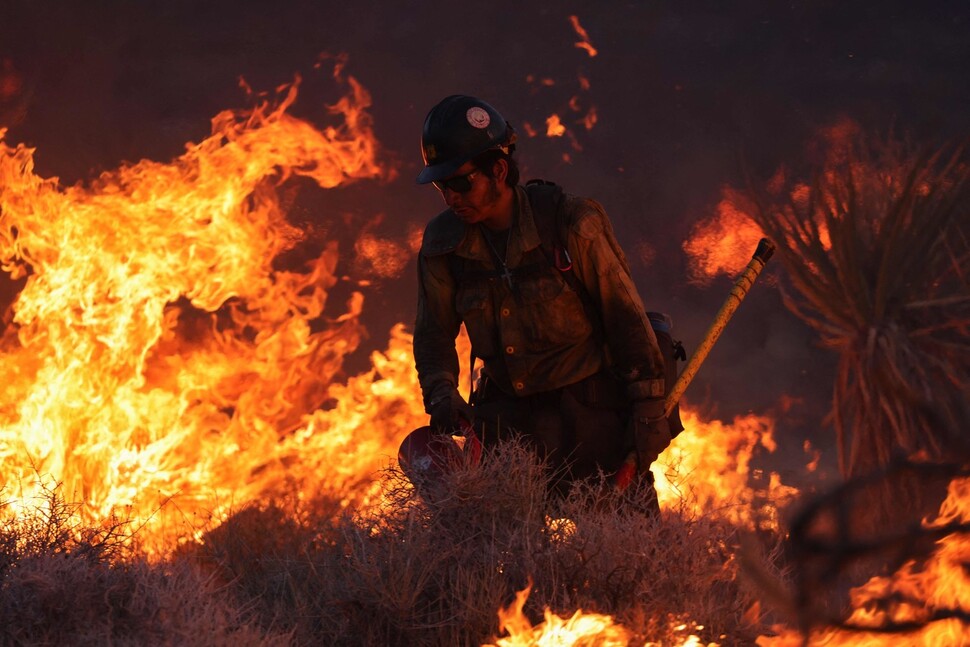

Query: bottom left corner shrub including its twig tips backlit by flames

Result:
[0,488,288,646]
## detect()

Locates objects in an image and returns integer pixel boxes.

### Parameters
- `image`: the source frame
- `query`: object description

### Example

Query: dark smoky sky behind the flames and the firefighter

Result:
[0,0,970,476]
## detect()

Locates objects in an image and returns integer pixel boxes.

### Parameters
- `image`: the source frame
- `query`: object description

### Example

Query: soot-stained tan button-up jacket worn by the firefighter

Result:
[414,186,664,407]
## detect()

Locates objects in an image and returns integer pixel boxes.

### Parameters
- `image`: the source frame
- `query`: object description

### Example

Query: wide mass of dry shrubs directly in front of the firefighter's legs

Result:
[191,442,788,646]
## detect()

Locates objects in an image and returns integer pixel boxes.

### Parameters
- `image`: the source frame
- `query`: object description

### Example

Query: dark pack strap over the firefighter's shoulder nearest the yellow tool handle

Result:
[525,179,606,344]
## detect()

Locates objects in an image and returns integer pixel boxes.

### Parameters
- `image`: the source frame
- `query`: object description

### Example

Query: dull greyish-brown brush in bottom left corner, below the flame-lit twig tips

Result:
[0,556,288,647]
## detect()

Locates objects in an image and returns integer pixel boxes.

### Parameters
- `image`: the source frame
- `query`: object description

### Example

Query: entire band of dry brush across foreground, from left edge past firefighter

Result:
[0,443,780,646]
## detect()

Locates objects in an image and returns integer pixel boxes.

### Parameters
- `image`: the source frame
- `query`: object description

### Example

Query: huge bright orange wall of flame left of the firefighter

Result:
[0,73,423,543]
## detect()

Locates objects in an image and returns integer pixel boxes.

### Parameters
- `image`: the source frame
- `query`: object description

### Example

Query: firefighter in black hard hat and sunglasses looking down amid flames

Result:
[414,95,670,502]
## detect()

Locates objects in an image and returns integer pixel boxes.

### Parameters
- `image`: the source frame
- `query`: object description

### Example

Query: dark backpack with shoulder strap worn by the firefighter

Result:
[525,179,687,437]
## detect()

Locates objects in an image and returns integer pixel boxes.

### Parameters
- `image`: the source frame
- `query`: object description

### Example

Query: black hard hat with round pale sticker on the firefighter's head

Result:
[418,94,515,184]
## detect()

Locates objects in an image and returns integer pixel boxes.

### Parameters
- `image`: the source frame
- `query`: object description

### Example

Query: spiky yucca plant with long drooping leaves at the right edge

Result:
[748,134,970,476]
